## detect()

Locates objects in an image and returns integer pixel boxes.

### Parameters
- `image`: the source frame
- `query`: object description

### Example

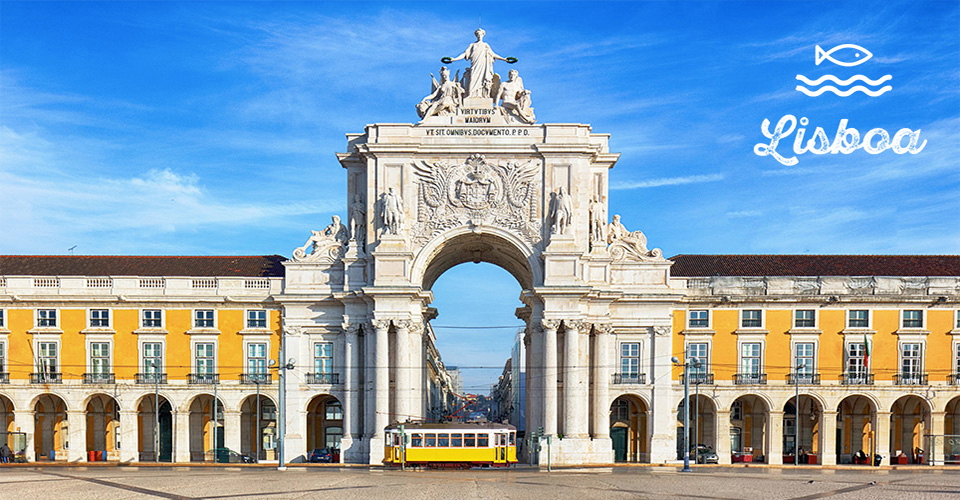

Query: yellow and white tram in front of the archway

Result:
[383,423,517,468]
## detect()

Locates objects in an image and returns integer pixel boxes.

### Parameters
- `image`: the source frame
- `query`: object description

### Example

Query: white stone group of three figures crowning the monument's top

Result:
[417,29,536,124]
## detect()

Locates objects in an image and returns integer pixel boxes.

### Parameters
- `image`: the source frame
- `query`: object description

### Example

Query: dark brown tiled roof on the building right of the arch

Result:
[670,255,960,277]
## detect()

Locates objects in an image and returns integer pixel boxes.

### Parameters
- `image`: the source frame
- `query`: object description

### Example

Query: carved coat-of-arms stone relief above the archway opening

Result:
[412,154,541,244]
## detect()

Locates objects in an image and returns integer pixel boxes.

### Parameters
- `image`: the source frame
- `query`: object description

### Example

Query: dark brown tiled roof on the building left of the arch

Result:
[0,255,286,277]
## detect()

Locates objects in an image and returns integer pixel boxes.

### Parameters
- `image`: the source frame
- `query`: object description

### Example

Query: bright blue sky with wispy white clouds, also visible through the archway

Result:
[0,1,960,387]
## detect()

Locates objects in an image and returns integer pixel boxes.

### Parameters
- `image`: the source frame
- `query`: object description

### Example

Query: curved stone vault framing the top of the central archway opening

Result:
[411,226,543,290]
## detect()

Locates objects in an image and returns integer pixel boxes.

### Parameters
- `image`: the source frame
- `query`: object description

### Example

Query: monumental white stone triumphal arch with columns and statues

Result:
[278,30,681,463]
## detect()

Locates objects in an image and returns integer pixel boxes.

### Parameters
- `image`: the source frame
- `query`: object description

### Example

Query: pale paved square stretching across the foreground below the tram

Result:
[0,466,960,500]
